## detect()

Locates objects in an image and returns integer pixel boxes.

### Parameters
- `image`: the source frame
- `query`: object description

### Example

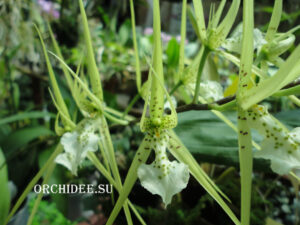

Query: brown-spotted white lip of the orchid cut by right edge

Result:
[246,106,300,175]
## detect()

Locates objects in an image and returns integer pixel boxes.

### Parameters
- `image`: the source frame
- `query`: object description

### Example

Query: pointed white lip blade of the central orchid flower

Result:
[138,161,189,206]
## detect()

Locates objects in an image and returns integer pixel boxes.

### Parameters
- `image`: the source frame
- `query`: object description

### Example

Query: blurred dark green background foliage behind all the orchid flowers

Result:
[0,0,300,225]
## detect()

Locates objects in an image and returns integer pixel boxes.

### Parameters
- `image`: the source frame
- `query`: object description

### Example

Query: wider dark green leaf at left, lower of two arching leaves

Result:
[1,126,55,154]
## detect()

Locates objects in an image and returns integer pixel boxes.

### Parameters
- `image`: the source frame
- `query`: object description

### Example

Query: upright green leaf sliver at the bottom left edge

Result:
[0,148,10,224]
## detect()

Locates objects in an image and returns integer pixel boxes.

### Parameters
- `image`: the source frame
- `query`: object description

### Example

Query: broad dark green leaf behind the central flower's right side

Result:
[174,111,271,171]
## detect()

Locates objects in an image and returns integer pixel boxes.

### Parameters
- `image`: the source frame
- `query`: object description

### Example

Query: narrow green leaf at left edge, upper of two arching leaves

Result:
[0,111,55,125]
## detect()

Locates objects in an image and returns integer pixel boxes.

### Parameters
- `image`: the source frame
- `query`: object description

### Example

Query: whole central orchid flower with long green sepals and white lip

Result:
[106,0,240,225]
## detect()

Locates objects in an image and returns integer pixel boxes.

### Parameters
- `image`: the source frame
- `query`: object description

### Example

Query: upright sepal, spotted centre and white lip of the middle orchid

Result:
[137,0,189,206]
